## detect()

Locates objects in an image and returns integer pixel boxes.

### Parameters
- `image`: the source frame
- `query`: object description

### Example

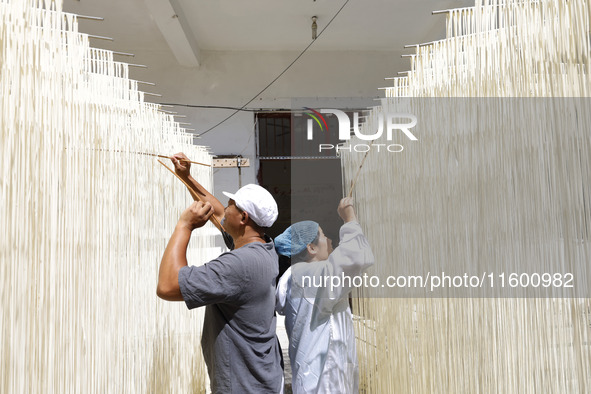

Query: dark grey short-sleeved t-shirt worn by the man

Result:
[179,242,283,393]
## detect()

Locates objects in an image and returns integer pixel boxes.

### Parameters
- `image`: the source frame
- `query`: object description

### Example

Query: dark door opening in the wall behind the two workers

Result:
[256,112,343,246]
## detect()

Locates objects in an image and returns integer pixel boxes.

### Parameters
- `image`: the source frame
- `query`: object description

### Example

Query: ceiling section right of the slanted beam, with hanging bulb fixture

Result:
[173,0,473,51]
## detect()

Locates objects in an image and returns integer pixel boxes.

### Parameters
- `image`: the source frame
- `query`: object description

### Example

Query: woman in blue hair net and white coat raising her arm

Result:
[275,198,374,394]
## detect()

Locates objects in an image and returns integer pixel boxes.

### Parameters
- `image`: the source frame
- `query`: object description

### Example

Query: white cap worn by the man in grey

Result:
[222,183,279,227]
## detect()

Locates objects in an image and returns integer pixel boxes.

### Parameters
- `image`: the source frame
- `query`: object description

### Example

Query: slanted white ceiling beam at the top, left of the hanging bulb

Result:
[144,0,200,67]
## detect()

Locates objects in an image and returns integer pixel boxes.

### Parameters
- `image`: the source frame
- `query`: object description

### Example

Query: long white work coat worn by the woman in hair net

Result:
[276,222,374,394]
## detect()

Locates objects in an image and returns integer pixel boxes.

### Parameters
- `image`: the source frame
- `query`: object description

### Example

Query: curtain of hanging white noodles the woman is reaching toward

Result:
[343,0,591,393]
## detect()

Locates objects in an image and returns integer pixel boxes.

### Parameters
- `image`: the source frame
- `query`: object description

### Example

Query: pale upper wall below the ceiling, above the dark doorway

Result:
[132,49,409,203]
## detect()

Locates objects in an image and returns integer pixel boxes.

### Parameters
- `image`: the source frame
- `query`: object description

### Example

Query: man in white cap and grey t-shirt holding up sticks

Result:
[157,154,283,393]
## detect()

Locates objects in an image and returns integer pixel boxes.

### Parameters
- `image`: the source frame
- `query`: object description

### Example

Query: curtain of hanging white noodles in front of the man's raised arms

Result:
[0,0,213,393]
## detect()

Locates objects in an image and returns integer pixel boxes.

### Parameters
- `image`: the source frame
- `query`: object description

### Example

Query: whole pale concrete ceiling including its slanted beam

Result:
[64,0,474,66]
